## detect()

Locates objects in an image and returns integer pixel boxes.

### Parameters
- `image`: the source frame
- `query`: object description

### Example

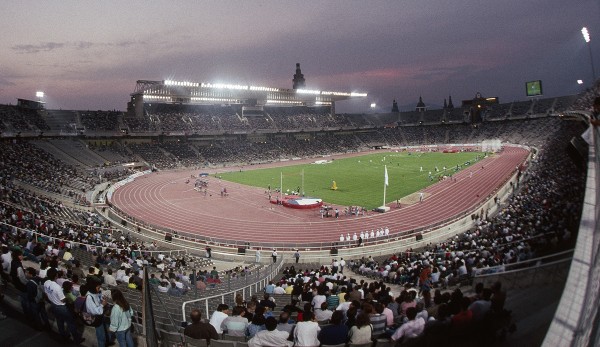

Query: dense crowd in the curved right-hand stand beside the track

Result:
[351,117,585,294]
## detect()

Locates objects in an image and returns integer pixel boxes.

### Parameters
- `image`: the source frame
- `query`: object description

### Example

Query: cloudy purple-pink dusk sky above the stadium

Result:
[0,0,600,112]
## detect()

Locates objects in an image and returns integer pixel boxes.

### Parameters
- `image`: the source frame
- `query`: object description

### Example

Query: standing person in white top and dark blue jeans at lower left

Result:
[44,268,85,344]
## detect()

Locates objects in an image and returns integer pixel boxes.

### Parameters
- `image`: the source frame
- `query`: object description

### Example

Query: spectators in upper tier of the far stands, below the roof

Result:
[0,92,597,137]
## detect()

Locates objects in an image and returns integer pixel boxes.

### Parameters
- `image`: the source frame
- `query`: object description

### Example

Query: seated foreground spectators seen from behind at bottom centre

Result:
[184,262,510,346]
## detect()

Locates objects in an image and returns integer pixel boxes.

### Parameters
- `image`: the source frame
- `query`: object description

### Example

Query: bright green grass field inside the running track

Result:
[219,152,482,209]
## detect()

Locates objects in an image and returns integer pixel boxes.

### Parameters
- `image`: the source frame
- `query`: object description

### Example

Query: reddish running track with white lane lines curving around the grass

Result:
[111,146,529,245]
